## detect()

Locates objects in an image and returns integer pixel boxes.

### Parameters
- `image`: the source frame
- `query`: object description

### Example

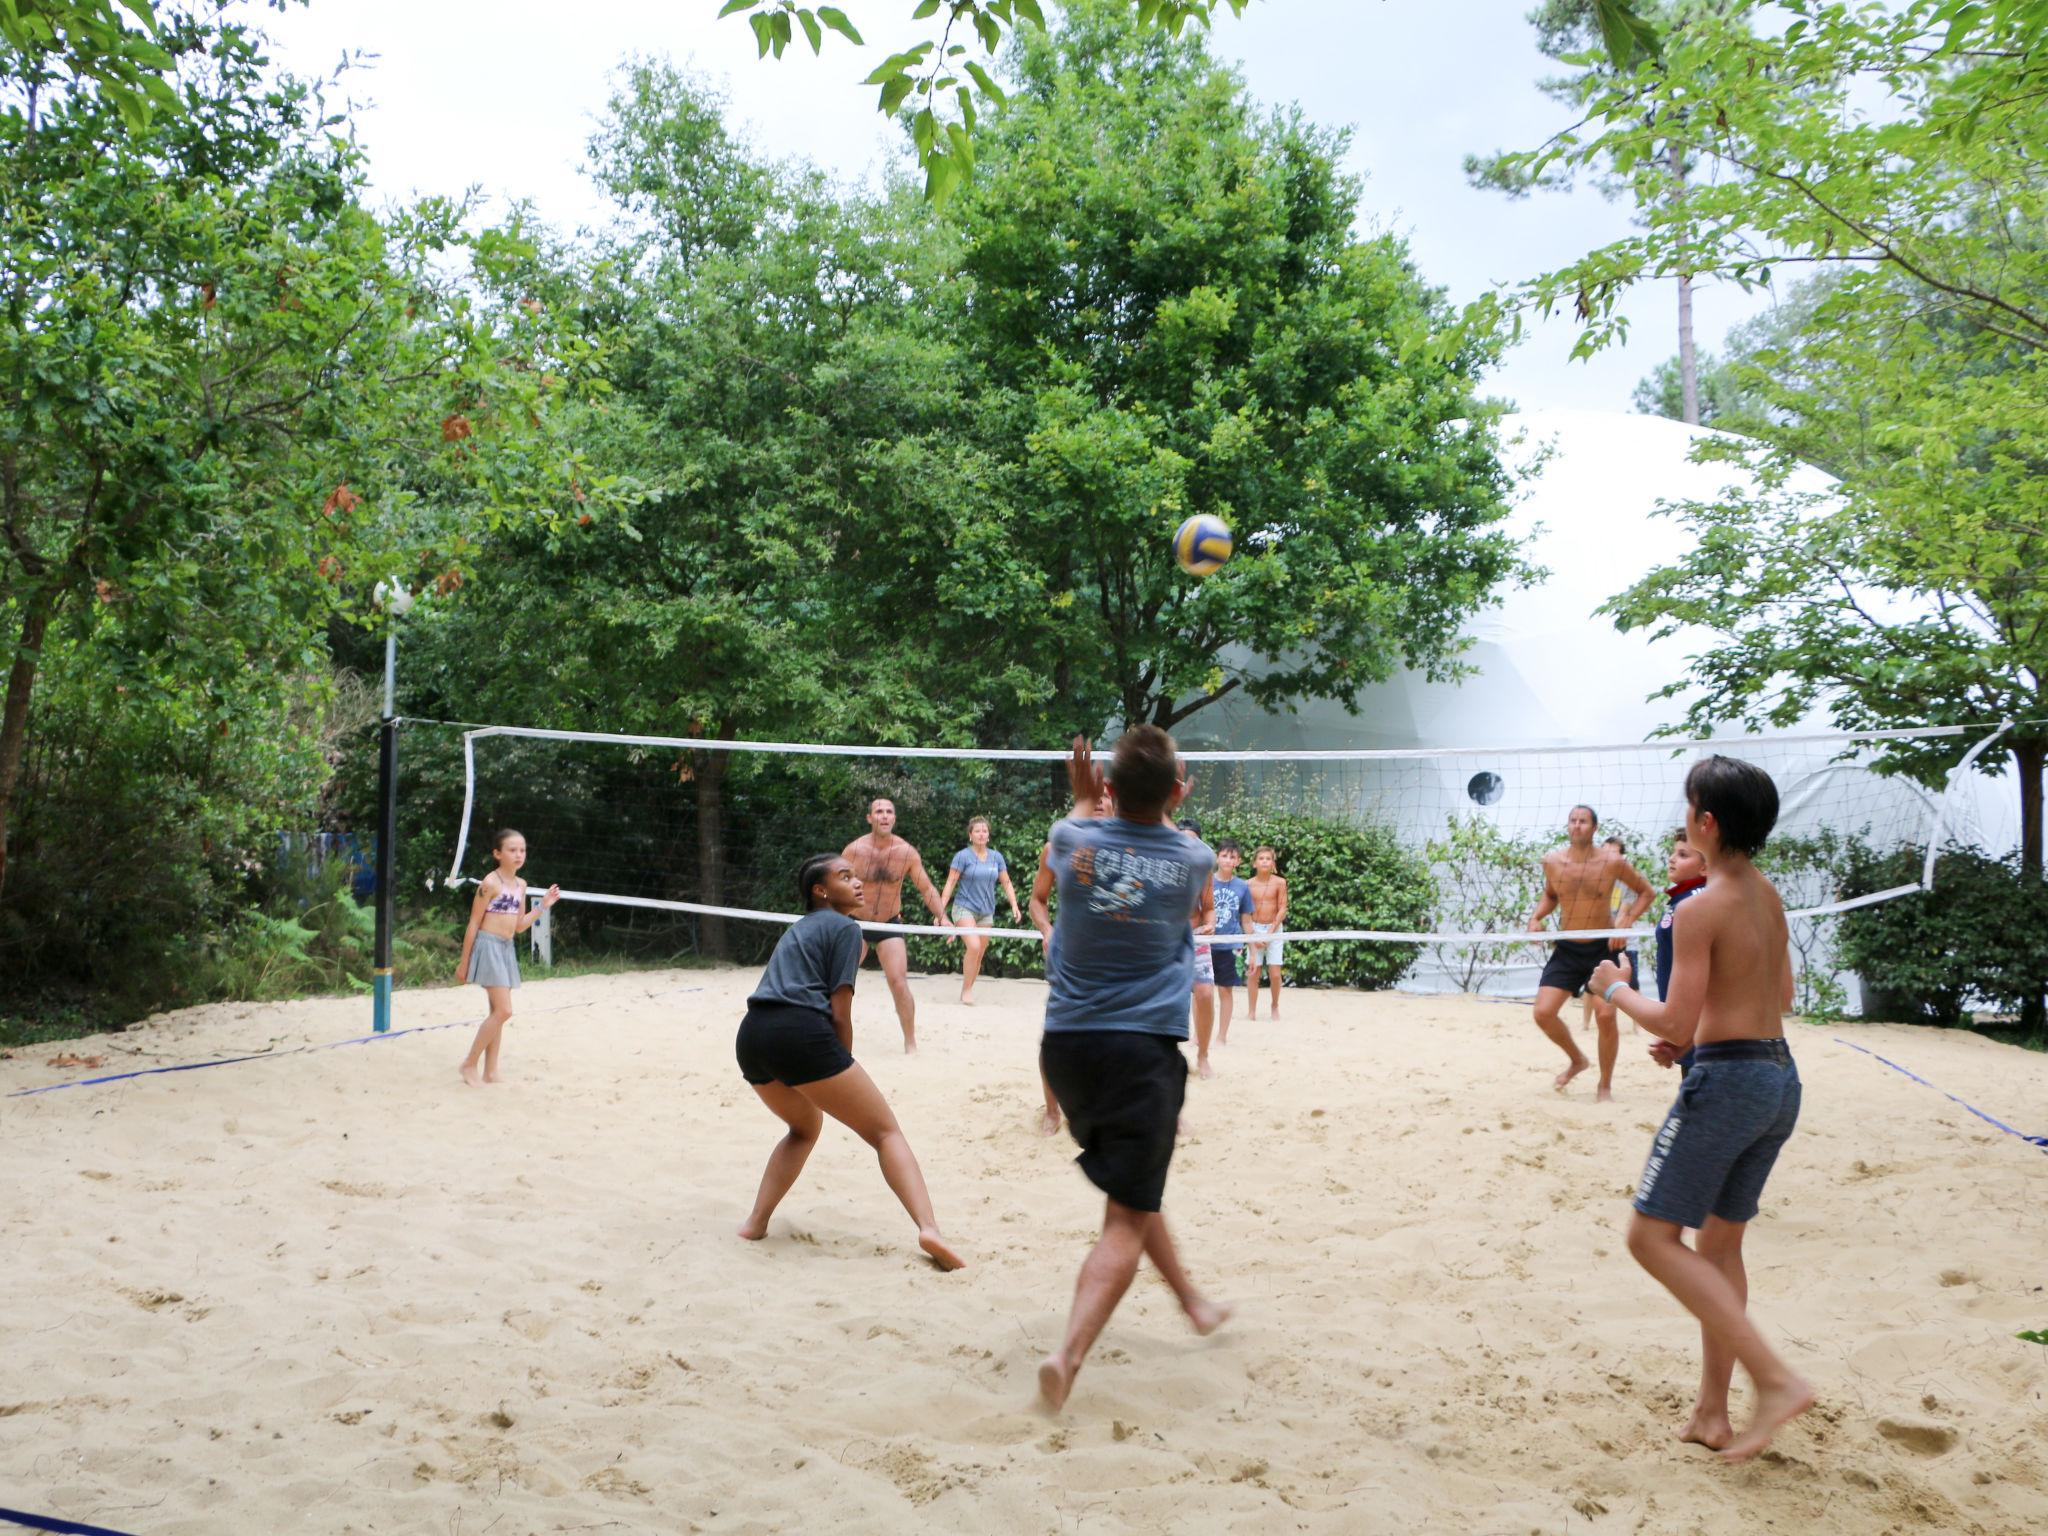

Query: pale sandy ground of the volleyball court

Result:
[0,971,2048,1536]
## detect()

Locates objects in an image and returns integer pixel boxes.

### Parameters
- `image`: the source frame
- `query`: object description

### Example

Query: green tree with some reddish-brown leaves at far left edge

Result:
[0,12,604,889]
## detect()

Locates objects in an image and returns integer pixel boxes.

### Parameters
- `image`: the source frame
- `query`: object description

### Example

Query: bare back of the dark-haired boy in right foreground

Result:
[1671,860,1792,1044]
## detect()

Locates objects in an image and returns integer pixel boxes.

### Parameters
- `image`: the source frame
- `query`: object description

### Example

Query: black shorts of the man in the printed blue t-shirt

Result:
[1038,1030,1188,1210]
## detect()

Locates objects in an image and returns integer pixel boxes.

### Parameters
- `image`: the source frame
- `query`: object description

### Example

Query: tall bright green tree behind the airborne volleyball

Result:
[934,2,1520,729]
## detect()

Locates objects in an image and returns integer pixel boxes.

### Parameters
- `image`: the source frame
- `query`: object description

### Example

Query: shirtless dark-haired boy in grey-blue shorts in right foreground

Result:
[1593,756,1815,1462]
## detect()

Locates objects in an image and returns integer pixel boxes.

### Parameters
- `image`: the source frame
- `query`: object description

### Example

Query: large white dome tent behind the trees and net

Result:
[1184,412,2019,995]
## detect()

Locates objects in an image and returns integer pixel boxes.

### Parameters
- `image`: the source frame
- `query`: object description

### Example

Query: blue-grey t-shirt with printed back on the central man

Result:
[1044,817,1217,1040]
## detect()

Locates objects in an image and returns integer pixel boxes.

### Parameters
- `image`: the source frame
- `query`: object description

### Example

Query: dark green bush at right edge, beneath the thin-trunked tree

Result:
[1835,848,2048,1024]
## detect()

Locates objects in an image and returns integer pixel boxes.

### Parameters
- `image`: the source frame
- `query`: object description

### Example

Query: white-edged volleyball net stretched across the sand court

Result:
[432,727,1995,991]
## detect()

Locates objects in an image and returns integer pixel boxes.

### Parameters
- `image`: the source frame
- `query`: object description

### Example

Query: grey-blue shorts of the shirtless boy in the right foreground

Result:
[1636,1038,1800,1227]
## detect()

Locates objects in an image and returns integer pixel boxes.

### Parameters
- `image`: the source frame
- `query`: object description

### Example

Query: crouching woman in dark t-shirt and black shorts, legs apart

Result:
[733,854,965,1270]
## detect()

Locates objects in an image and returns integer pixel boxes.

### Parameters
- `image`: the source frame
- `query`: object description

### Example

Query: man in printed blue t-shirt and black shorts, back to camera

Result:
[1038,725,1231,1409]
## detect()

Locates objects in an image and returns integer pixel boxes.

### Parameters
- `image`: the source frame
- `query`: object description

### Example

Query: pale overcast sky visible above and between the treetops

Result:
[260,0,1759,410]
